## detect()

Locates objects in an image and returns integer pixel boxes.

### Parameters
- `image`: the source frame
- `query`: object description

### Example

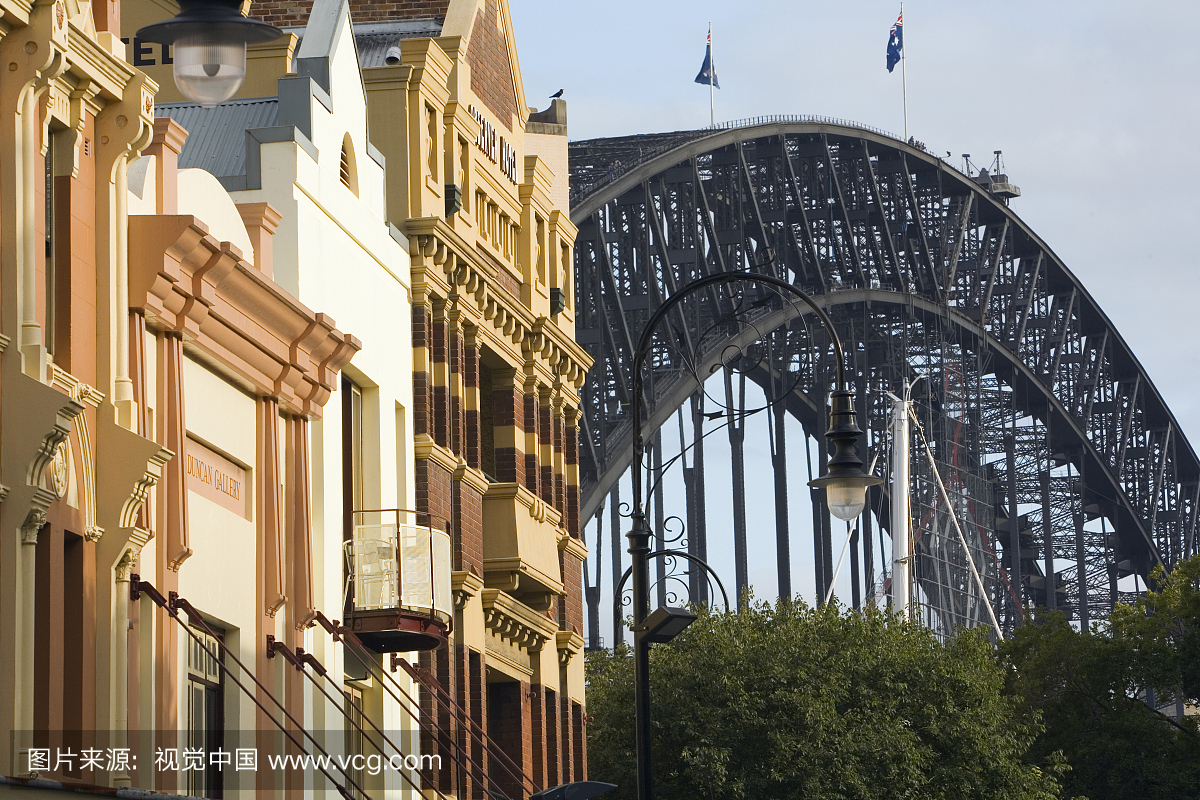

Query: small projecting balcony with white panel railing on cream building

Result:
[343,509,454,652]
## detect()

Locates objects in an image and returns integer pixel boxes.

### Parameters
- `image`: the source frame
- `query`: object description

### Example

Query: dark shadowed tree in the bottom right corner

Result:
[1000,558,1200,800]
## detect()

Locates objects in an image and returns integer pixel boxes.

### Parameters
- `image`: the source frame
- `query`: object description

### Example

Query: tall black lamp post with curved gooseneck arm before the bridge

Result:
[626,271,883,800]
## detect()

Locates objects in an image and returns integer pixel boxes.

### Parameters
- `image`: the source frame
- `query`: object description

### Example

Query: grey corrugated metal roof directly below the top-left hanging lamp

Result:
[155,97,280,178]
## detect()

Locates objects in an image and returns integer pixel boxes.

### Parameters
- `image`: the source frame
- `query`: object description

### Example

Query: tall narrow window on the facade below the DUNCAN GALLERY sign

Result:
[181,626,224,798]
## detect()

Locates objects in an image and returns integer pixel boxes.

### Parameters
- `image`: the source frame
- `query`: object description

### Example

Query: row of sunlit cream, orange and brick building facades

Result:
[0,0,589,798]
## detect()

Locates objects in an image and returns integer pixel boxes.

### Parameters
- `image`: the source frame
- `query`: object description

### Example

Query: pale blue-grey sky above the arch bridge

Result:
[511,0,1200,618]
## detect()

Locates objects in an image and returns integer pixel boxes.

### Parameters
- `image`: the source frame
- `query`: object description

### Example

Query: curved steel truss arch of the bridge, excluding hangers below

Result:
[571,124,1200,622]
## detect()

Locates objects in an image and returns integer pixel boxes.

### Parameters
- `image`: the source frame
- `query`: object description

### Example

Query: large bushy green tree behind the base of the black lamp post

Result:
[588,601,1058,800]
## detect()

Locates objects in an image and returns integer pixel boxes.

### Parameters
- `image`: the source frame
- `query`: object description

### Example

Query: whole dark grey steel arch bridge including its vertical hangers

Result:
[570,118,1200,646]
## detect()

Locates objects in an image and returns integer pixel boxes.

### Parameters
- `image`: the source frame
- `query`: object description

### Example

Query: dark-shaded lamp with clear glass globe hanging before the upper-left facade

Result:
[137,0,283,108]
